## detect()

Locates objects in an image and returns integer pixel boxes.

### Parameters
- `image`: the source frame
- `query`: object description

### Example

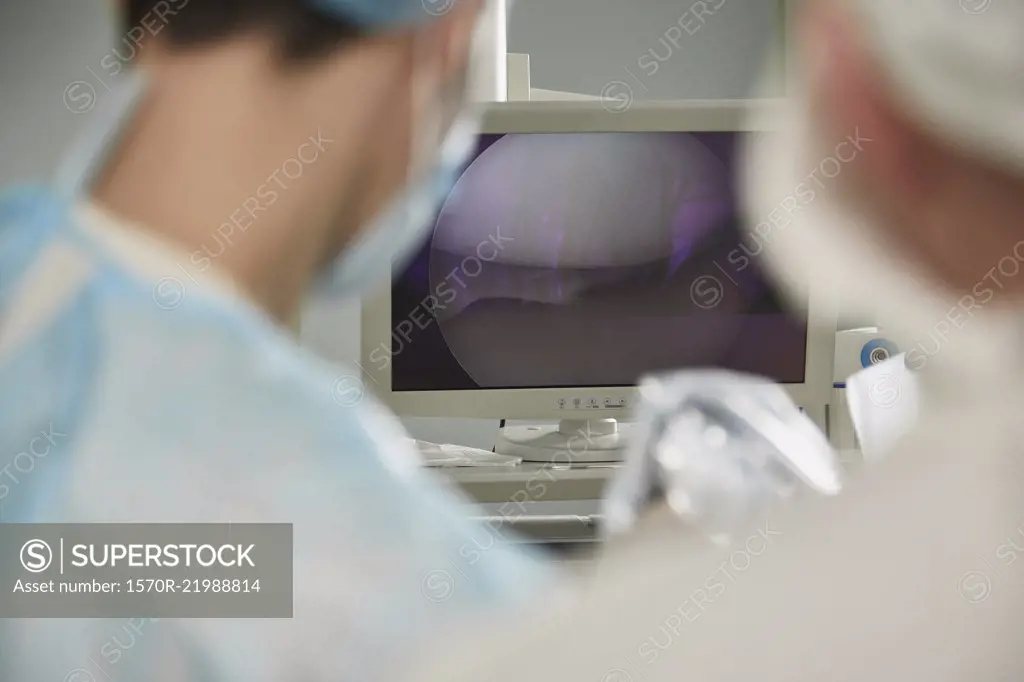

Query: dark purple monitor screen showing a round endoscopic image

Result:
[381,132,807,391]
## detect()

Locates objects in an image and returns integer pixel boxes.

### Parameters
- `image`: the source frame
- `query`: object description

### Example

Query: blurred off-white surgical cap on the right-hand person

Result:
[849,0,1024,172]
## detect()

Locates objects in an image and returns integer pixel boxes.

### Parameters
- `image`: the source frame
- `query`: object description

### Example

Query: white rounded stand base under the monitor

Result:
[495,419,630,466]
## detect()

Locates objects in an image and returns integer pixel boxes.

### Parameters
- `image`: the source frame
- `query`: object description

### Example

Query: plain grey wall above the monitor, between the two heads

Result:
[509,0,782,99]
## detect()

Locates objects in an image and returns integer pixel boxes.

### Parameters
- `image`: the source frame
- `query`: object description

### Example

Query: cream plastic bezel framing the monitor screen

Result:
[359,100,837,428]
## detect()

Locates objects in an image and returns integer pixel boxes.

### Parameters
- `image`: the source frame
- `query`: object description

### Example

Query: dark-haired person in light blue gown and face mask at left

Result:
[0,0,549,682]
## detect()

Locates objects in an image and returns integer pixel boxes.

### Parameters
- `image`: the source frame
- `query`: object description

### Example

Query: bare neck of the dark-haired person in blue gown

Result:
[93,48,360,327]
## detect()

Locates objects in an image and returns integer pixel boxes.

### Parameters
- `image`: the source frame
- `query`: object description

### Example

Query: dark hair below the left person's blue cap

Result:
[124,0,360,61]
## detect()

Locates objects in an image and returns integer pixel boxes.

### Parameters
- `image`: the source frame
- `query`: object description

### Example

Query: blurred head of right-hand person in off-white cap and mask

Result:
[746,0,1024,391]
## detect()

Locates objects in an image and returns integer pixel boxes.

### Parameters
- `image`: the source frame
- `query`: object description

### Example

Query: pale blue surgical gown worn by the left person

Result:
[0,186,550,682]
